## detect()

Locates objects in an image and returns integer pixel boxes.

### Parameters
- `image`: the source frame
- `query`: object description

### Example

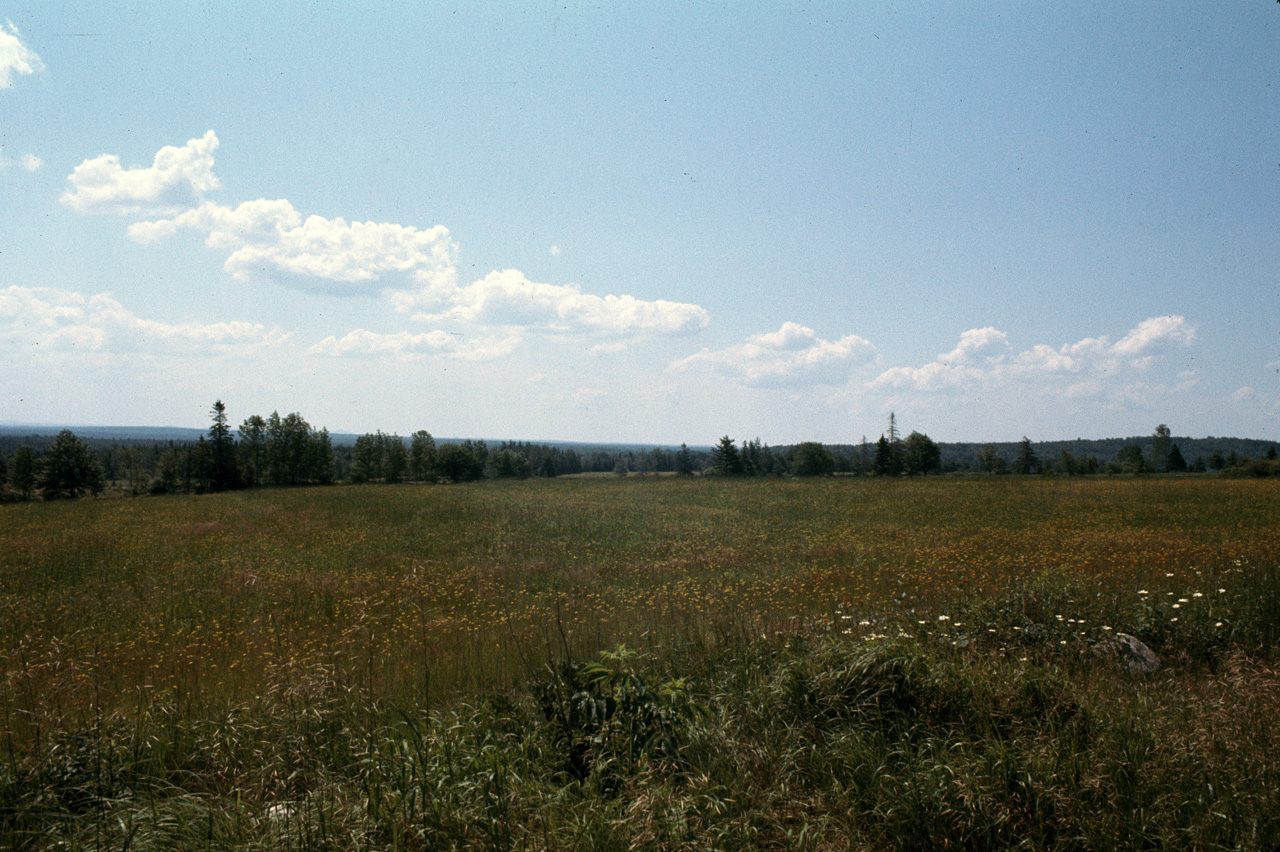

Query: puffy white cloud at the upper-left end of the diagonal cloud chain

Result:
[61,130,219,214]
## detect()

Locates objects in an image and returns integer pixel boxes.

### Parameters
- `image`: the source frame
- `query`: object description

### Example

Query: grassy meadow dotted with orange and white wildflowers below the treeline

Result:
[0,477,1280,849]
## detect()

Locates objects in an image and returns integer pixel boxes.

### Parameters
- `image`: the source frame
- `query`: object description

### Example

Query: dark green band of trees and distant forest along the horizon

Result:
[0,400,1280,500]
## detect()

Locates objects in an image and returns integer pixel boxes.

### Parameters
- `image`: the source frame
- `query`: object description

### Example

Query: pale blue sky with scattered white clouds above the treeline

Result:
[0,0,1280,445]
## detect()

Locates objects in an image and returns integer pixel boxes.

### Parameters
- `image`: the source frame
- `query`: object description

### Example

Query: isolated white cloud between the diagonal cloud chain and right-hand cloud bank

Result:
[671,322,876,388]
